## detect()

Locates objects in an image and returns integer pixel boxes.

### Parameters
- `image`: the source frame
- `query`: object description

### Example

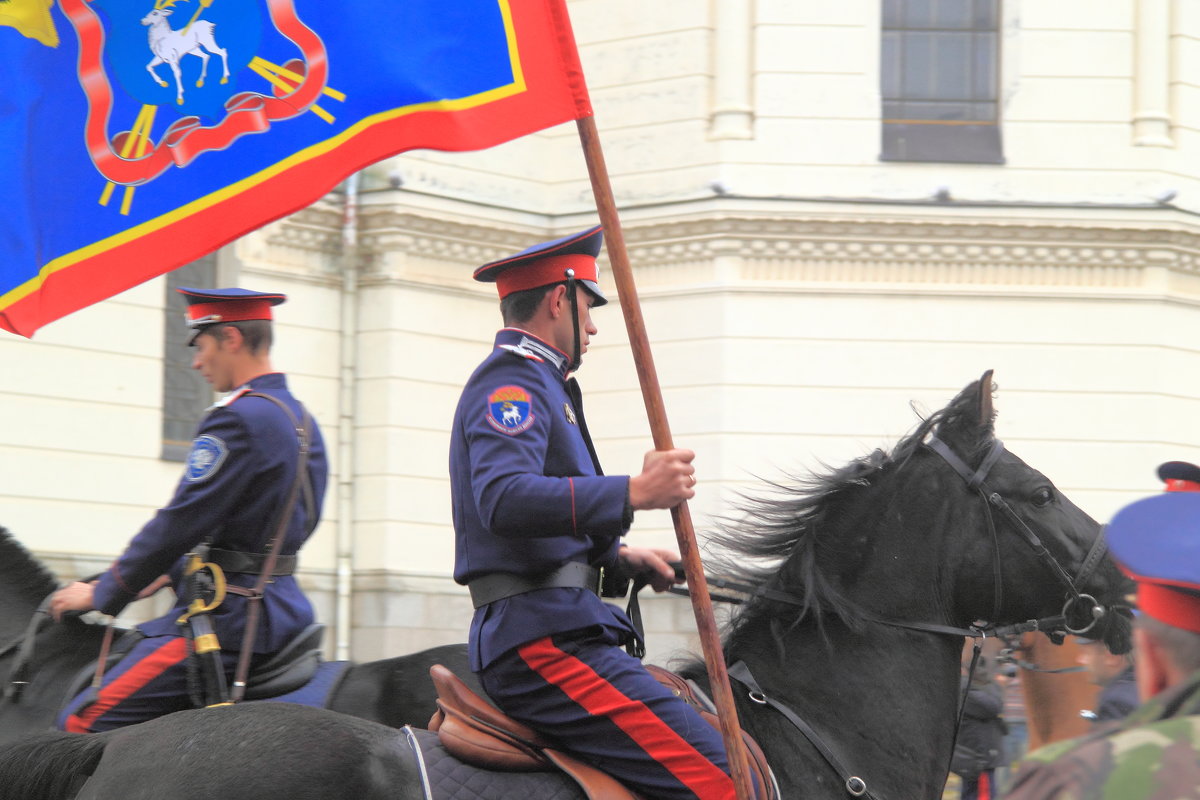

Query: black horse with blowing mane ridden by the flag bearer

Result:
[0,373,1129,800]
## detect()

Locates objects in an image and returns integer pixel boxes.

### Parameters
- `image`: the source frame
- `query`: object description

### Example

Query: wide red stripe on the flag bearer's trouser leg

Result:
[517,637,736,800]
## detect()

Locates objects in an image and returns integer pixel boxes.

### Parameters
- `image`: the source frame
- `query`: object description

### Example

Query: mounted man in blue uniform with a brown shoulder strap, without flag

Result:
[50,289,328,733]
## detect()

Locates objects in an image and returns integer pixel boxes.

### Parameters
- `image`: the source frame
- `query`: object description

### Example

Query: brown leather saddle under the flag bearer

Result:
[428,664,778,800]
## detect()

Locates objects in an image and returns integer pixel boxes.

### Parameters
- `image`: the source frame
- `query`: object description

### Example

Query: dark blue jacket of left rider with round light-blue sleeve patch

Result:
[95,373,329,652]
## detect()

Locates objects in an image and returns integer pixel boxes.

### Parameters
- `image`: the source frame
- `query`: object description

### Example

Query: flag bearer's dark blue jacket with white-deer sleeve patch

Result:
[450,329,632,672]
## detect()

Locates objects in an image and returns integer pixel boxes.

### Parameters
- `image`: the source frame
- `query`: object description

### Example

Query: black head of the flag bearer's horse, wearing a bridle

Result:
[920,371,1130,652]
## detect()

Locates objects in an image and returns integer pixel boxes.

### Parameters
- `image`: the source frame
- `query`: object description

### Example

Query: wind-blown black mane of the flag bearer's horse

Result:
[709,373,995,642]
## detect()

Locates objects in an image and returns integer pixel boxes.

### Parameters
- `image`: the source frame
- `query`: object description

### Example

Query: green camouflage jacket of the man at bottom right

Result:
[1003,673,1200,800]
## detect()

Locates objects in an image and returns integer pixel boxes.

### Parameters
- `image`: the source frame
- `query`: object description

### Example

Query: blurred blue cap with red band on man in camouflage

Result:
[1105,492,1200,633]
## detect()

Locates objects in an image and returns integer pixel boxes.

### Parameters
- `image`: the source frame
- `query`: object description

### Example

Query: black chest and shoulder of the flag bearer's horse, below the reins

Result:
[727,620,962,800]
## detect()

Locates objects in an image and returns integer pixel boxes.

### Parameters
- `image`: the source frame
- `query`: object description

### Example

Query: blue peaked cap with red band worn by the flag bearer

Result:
[475,225,608,306]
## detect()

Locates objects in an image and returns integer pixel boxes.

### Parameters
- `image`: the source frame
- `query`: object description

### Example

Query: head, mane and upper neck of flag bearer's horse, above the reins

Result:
[713,371,1130,652]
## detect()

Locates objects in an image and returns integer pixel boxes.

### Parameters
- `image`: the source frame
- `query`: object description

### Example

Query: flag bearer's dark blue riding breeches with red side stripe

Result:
[479,626,736,800]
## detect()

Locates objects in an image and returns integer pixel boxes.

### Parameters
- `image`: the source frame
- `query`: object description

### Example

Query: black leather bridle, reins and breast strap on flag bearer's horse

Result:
[657,435,1108,800]
